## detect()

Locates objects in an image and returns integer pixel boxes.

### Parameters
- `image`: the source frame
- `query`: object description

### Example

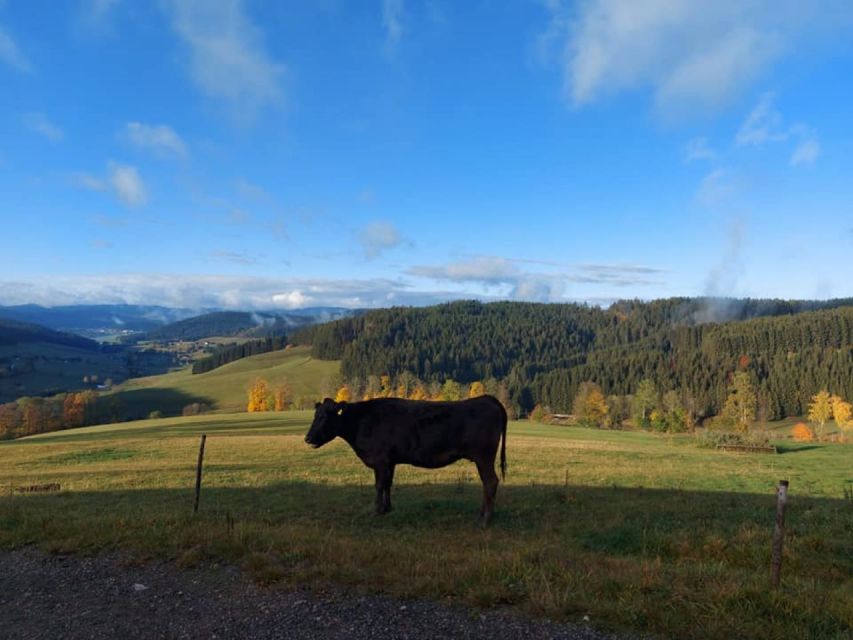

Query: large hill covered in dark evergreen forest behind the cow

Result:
[291,298,853,419]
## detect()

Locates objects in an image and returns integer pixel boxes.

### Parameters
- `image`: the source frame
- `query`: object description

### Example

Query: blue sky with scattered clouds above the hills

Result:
[0,0,853,308]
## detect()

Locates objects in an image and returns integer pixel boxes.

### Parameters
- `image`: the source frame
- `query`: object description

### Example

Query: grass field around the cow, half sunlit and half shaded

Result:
[0,412,853,638]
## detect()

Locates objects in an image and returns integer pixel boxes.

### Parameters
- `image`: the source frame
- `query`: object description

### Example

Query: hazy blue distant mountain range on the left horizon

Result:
[0,304,354,340]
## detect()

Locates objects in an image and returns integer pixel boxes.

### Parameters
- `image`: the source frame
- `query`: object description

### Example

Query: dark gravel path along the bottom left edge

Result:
[0,550,636,640]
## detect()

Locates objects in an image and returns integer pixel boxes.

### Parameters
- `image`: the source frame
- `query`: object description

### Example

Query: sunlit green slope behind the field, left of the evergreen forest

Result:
[109,347,340,412]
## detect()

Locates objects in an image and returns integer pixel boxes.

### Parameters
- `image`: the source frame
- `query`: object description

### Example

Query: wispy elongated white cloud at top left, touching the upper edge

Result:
[166,0,284,121]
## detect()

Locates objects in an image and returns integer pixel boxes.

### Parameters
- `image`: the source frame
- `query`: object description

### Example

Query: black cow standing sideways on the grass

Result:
[305,396,506,526]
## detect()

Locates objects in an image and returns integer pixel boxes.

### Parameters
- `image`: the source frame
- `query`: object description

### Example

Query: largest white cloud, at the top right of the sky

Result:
[543,0,853,112]
